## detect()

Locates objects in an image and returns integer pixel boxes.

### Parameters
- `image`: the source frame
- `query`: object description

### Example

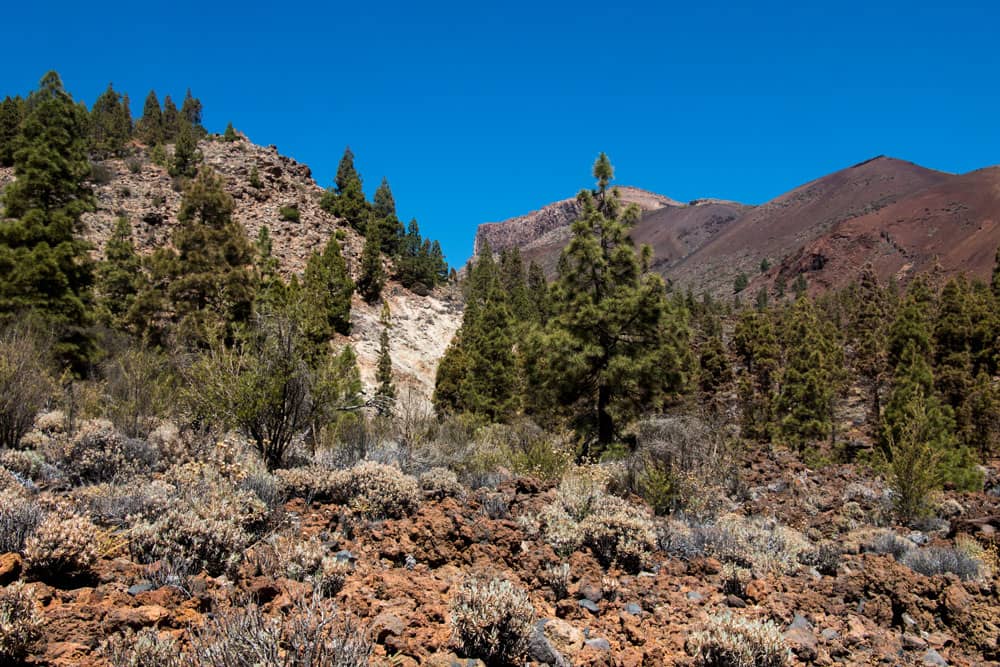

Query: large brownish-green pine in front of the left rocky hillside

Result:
[148,169,254,346]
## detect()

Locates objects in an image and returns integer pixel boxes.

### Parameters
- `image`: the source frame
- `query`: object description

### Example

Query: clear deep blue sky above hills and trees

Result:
[0,0,1000,265]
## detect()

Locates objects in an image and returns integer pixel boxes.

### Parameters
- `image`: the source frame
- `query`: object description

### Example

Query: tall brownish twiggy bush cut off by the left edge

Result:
[0,329,53,449]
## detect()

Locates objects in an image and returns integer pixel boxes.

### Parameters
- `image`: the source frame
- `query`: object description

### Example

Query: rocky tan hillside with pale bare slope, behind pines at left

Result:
[0,136,462,403]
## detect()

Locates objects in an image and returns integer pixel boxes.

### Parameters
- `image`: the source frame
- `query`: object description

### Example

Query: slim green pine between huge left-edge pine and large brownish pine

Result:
[95,217,142,330]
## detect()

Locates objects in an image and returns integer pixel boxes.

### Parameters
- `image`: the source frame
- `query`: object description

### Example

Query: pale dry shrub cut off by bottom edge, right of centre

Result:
[687,613,791,667]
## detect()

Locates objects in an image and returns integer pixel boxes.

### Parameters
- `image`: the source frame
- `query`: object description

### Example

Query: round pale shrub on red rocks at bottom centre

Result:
[451,577,535,667]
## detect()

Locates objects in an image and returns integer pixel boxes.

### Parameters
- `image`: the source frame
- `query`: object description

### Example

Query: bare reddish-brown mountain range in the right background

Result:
[477,156,1000,295]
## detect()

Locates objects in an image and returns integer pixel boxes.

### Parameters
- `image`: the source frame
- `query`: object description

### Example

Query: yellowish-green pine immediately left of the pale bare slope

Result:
[302,236,354,348]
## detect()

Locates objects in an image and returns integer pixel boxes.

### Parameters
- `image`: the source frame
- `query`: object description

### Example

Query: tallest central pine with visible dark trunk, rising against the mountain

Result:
[526,153,690,448]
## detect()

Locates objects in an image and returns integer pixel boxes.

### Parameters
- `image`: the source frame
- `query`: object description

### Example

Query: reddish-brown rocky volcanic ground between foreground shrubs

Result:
[0,420,1000,666]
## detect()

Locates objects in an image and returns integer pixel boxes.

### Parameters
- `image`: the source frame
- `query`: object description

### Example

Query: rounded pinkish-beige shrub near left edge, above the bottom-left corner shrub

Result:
[24,512,97,577]
